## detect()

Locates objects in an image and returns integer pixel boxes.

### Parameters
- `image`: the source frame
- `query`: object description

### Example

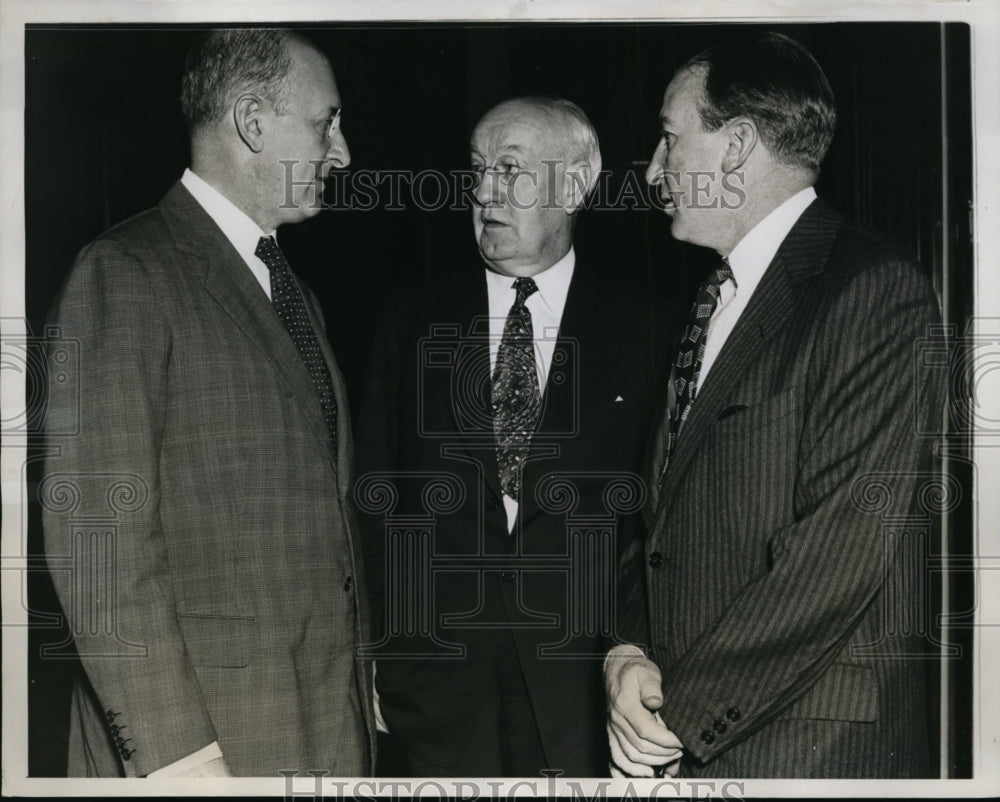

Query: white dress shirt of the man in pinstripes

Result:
[698,187,816,389]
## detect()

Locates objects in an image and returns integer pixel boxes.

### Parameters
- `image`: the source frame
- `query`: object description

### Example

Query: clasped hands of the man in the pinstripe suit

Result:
[604,646,684,777]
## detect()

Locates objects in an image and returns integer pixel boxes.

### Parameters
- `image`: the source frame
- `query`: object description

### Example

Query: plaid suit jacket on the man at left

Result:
[41,184,373,776]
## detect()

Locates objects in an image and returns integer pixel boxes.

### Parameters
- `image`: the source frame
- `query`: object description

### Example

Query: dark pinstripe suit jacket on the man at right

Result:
[645,200,944,777]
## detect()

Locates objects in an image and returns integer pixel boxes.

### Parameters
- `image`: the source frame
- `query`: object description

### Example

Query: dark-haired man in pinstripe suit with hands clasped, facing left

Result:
[607,34,944,777]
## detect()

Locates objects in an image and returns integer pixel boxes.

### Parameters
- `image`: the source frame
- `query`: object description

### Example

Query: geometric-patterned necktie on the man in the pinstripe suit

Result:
[660,259,733,476]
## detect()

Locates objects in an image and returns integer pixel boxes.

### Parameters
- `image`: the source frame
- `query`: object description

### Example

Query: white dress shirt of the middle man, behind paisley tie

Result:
[486,247,576,532]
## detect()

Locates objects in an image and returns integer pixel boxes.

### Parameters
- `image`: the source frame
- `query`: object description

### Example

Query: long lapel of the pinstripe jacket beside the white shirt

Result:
[653,199,842,517]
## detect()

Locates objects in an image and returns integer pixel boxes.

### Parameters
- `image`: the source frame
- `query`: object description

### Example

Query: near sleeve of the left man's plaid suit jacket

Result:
[42,241,217,776]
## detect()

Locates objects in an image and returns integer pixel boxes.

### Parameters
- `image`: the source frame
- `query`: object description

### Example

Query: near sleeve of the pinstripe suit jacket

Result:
[661,253,944,760]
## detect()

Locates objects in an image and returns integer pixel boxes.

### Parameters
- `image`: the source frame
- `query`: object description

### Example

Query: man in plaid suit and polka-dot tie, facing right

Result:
[40,29,374,777]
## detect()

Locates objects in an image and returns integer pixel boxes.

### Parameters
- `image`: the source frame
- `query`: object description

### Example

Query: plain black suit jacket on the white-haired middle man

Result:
[358,256,669,776]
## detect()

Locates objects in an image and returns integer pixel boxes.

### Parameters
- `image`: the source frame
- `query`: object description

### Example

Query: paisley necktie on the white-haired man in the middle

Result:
[493,278,542,501]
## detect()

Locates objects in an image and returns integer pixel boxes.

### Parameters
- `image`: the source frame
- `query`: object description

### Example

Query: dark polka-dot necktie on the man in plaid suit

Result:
[254,237,337,452]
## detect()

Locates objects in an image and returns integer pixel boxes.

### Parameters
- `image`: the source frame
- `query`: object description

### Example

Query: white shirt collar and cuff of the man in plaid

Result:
[146,169,274,777]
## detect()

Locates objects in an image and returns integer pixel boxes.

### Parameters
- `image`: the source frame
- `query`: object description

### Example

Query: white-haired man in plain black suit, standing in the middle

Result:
[357,98,665,777]
